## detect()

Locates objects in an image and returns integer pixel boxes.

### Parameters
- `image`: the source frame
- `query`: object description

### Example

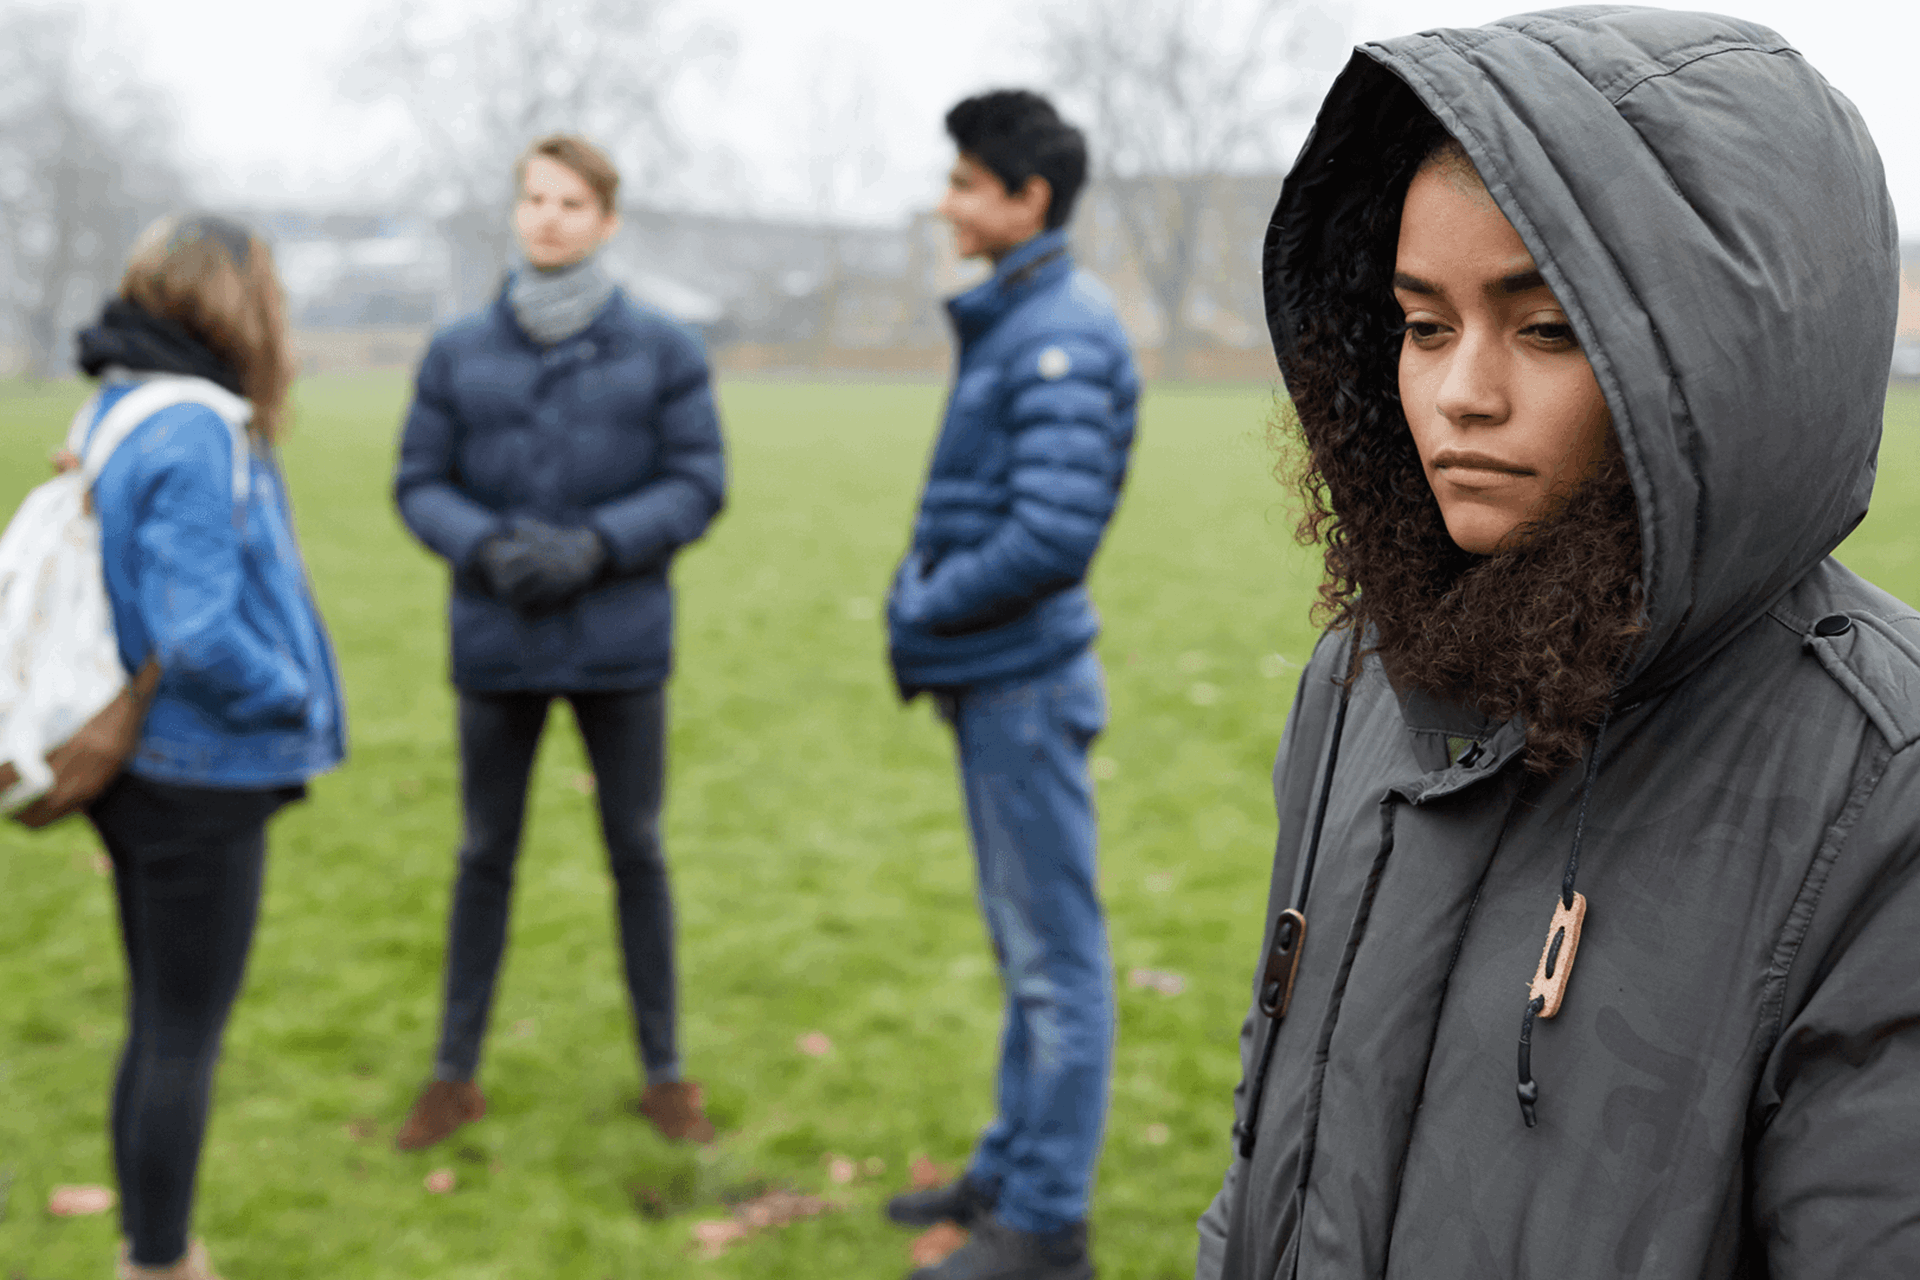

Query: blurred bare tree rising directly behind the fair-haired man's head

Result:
[348,0,732,307]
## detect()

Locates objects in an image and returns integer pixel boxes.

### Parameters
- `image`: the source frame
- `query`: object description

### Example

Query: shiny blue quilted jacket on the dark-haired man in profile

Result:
[887,230,1140,699]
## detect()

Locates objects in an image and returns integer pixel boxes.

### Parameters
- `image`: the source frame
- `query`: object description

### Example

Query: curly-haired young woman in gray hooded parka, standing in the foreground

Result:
[1198,8,1920,1280]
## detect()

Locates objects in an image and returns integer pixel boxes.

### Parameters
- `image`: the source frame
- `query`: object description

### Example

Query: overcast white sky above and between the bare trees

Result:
[74,0,1920,240]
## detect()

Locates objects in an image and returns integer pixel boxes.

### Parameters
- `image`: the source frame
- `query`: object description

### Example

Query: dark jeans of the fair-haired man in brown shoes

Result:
[434,685,680,1080]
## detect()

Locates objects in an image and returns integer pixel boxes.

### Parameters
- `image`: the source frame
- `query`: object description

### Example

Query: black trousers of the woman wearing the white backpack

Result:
[86,773,301,1267]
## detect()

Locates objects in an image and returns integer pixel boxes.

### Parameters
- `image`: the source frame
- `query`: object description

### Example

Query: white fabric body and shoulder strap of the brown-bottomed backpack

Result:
[0,374,253,814]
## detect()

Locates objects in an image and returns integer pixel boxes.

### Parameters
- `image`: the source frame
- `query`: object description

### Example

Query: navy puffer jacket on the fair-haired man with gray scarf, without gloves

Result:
[394,292,726,691]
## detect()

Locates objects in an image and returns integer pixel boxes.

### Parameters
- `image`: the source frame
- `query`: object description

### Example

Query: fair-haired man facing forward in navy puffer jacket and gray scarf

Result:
[394,134,726,1150]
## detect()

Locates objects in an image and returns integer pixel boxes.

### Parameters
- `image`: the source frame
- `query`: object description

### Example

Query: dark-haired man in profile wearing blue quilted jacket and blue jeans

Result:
[887,90,1140,1280]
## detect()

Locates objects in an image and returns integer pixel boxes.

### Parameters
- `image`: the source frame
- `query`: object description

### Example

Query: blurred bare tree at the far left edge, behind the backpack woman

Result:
[0,6,186,374]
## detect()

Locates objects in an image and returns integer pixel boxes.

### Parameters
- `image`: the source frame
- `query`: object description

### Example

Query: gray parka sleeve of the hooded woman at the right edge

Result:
[1753,745,1920,1280]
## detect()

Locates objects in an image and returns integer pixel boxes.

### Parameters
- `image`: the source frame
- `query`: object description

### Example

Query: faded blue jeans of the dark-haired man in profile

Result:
[943,651,1114,1232]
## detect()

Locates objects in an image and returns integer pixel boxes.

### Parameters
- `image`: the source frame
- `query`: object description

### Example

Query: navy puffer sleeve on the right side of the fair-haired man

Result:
[588,330,726,574]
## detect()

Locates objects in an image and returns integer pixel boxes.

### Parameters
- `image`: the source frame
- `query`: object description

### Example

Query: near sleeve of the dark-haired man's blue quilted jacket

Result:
[895,334,1135,633]
